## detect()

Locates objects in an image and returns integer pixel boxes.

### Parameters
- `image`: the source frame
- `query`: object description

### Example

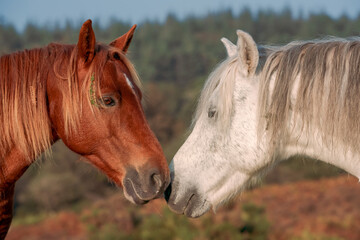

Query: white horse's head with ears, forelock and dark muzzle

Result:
[165,30,259,217]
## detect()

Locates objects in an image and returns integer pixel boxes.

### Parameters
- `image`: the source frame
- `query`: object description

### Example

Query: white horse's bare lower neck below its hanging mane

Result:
[254,71,360,178]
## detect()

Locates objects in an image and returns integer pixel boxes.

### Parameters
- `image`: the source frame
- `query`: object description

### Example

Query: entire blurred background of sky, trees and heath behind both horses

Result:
[0,0,360,240]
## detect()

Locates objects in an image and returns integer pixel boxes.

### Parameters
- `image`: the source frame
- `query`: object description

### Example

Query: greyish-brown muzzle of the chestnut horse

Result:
[123,167,170,204]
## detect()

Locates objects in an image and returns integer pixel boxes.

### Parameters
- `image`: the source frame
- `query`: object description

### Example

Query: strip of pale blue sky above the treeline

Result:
[0,0,360,31]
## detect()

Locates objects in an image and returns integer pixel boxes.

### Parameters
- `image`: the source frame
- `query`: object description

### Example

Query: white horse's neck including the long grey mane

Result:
[259,40,360,180]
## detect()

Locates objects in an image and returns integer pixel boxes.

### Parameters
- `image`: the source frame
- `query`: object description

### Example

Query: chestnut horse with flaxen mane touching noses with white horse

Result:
[0,20,169,239]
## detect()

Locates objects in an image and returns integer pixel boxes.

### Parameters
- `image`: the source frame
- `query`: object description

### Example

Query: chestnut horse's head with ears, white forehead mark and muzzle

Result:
[47,20,169,204]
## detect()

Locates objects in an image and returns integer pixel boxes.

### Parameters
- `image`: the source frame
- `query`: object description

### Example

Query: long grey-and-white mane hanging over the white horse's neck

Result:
[258,38,360,156]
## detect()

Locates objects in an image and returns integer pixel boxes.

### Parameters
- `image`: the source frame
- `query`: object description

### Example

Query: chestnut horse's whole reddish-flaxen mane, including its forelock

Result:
[0,44,141,161]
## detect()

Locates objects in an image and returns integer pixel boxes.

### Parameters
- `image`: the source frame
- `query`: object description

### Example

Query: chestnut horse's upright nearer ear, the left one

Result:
[77,19,96,65]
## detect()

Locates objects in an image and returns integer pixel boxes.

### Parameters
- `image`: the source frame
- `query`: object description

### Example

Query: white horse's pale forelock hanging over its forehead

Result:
[193,56,240,129]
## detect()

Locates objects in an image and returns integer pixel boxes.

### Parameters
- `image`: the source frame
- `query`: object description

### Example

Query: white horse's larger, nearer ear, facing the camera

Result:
[236,30,259,76]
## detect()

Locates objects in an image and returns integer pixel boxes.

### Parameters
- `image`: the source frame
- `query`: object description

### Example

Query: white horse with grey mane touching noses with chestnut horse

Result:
[165,30,360,217]
